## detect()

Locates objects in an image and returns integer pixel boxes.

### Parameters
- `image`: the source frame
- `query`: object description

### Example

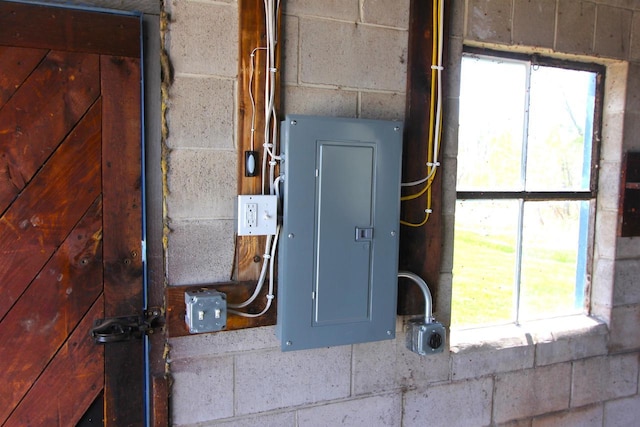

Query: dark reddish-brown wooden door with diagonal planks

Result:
[0,1,144,426]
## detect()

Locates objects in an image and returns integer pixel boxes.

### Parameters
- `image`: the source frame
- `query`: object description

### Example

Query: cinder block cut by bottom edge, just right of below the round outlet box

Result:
[402,378,493,427]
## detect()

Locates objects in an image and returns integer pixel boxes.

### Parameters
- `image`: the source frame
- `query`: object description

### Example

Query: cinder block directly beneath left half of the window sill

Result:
[451,345,535,380]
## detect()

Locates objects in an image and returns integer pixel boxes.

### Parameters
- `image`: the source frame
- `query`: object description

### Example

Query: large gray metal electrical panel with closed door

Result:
[276,115,402,351]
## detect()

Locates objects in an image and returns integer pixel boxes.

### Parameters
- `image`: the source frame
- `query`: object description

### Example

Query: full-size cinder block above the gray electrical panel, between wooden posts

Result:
[300,18,407,92]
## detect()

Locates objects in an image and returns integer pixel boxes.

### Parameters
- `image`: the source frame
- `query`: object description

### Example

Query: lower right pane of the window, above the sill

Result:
[520,201,588,320]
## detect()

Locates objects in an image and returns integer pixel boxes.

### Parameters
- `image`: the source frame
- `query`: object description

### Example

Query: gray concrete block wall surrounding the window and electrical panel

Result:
[164,0,640,427]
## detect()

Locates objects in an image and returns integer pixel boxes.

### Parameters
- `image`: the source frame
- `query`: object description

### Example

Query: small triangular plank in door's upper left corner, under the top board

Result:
[0,46,47,109]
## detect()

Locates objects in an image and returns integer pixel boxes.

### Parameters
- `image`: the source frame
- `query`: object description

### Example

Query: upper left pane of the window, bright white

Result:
[457,57,526,191]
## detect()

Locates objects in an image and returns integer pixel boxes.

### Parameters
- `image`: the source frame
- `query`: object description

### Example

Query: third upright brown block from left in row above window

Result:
[556,1,596,54]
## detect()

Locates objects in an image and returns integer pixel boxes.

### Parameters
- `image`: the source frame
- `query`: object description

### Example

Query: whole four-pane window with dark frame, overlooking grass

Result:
[452,51,604,327]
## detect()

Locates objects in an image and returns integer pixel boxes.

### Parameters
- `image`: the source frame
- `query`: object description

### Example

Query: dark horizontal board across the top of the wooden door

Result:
[0,2,140,58]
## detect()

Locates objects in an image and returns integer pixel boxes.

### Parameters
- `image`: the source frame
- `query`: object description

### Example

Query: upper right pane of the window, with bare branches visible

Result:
[526,67,595,191]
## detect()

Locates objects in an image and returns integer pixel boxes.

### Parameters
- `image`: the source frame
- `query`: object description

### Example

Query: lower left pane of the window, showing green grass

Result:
[451,200,518,327]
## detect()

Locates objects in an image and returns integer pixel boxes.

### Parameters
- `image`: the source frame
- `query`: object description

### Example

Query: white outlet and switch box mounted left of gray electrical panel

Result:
[236,195,278,236]
